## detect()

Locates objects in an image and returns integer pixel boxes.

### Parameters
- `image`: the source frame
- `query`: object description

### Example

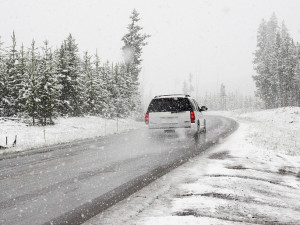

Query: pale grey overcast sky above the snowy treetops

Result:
[0,0,300,102]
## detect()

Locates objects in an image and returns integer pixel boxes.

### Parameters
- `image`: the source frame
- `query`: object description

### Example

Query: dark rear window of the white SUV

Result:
[148,98,192,112]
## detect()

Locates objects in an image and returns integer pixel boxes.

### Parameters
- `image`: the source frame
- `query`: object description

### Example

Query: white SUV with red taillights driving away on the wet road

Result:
[145,94,207,133]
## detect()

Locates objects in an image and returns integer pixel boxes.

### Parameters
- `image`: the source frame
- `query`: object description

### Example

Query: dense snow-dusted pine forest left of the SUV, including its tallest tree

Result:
[0,10,150,125]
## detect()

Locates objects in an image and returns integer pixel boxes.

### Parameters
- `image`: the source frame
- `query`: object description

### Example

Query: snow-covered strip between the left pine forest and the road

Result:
[0,116,145,154]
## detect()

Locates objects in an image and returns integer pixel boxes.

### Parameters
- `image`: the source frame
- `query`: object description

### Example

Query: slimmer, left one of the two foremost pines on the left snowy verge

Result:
[25,40,41,125]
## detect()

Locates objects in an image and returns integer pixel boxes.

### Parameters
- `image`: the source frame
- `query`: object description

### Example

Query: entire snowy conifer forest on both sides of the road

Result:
[0,10,300,125]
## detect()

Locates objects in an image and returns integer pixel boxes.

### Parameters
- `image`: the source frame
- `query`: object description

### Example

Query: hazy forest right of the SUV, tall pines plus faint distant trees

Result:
[188,13,300,111]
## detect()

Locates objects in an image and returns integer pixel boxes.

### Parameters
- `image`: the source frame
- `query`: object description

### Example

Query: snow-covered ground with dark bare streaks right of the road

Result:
[86,108,300,225]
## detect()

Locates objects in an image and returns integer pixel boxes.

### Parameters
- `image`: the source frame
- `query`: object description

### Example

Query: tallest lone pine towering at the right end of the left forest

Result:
[122,9,150,115]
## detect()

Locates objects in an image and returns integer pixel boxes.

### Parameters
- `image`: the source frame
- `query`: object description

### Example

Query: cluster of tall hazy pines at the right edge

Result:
[253,14,300,109]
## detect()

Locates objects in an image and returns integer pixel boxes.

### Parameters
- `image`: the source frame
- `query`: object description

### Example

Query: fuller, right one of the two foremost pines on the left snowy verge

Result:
[38,41,60,126]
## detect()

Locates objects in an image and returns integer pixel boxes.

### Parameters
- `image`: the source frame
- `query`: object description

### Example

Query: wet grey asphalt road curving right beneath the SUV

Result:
[0,116,237,225]
